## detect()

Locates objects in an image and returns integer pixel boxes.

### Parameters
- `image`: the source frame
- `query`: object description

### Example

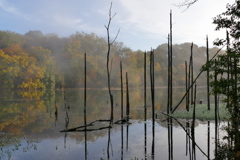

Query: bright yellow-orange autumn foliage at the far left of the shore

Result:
[0,45,54,89]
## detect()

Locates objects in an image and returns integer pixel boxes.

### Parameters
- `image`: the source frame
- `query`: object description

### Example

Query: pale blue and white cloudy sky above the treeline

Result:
[0,0,235,51]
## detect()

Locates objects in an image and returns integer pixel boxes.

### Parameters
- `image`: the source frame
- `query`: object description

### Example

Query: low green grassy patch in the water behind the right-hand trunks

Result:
[171,104,230,121]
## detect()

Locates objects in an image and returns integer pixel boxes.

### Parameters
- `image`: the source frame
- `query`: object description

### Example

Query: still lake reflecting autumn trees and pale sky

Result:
[0,88,224,160]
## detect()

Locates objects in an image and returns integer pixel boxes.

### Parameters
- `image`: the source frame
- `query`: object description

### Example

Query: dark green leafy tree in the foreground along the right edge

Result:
[205,0,240,159]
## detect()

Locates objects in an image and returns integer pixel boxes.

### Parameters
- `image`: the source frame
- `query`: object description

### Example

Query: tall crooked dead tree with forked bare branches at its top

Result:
[105,3,120,126]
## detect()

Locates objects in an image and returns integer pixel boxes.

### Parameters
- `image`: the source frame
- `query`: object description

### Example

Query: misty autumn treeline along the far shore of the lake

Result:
[0,31,224,90]
